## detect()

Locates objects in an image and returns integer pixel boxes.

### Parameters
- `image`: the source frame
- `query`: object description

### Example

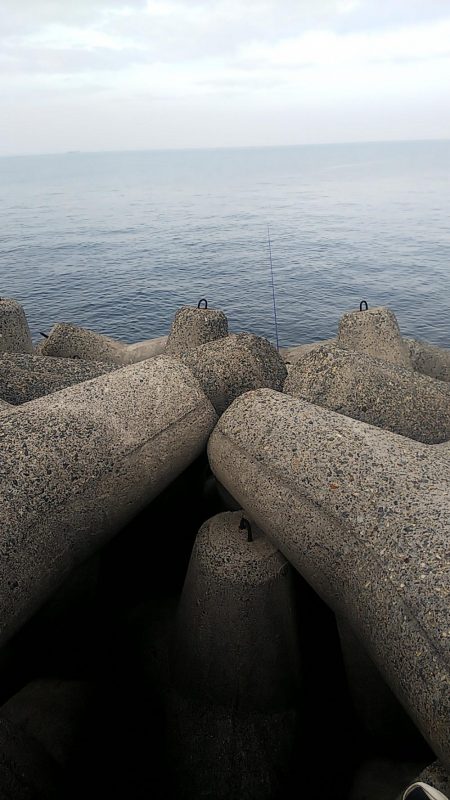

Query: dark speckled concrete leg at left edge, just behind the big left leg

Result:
[0,353,117,405]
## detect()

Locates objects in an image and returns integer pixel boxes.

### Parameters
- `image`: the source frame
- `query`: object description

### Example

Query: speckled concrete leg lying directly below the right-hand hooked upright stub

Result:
[284,342,450,444]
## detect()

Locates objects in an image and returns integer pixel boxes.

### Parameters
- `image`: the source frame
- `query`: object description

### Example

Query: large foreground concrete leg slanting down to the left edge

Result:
[0,356,217,643]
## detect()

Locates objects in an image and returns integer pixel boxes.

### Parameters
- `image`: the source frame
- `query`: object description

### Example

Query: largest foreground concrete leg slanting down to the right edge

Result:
[209,389,450,769]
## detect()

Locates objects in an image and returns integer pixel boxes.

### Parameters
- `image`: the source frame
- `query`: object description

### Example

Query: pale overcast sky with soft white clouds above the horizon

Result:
[0,0,450,155]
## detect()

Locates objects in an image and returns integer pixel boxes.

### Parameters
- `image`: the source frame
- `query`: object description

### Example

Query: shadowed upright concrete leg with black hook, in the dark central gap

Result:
[169,511,300,800]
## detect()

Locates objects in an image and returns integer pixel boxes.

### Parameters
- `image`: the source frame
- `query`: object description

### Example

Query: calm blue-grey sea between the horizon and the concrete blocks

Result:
[0,142,450,346]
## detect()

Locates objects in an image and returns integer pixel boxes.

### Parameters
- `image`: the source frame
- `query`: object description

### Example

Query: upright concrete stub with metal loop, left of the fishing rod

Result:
[166,306,228,355]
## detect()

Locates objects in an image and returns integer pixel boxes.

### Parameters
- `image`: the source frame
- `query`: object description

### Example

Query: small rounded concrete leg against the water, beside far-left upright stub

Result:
[40,322,126,364]
